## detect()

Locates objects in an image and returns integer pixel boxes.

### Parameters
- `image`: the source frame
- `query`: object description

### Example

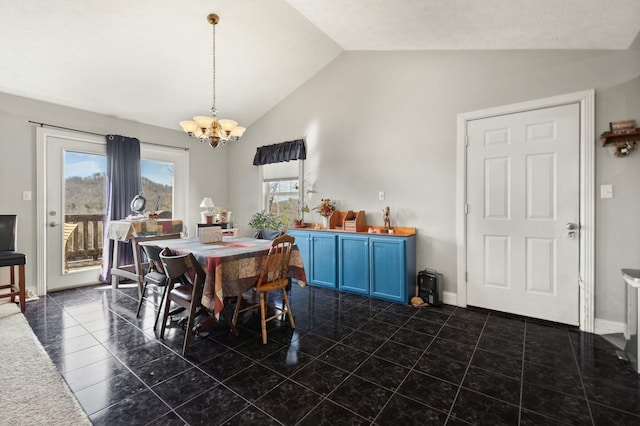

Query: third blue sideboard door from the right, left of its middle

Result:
[307,232,338,288]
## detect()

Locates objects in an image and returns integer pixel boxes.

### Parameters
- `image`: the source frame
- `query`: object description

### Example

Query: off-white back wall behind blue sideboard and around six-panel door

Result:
[229,50,640,322]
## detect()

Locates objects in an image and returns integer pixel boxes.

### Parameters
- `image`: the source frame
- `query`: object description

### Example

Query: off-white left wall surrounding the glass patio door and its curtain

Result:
[0,93,229,293]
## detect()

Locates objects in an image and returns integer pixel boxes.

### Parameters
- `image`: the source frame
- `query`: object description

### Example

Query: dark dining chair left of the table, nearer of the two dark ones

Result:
[160,249,205,356]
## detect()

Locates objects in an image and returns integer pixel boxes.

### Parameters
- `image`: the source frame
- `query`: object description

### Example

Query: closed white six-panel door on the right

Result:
[466,103,580,325]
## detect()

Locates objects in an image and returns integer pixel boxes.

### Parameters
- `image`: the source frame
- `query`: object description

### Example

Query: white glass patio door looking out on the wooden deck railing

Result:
[38,129,106,291]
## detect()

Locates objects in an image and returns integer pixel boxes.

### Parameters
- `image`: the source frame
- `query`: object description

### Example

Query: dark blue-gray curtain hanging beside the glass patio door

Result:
[100,135,142,282]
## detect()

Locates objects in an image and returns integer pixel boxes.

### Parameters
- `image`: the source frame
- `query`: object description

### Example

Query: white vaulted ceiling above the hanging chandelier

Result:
[0,0,640,129]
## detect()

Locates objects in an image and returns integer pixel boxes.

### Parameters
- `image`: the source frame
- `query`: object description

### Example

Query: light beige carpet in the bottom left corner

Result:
[0,303,91,426]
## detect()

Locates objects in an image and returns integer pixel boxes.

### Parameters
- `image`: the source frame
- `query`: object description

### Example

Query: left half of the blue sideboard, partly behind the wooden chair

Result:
[287,230,338,289]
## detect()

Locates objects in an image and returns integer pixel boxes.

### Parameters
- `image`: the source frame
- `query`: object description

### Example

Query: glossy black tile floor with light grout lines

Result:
[26,285,640,425]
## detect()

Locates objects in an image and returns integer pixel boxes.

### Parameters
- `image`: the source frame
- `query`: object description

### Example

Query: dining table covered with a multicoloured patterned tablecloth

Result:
[140,237,307,318]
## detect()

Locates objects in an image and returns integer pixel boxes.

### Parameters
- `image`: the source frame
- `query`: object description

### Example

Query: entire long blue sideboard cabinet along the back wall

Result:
[289,230,416,303]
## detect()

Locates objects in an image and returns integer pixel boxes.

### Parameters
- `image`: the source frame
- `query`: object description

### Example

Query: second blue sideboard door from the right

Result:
[338,234,369,295]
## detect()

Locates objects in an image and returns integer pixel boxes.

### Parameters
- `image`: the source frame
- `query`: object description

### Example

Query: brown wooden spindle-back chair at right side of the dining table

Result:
[233,235,296,344]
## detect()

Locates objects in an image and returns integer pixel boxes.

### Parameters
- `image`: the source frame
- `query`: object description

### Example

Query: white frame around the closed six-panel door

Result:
[456,90,595,333]
